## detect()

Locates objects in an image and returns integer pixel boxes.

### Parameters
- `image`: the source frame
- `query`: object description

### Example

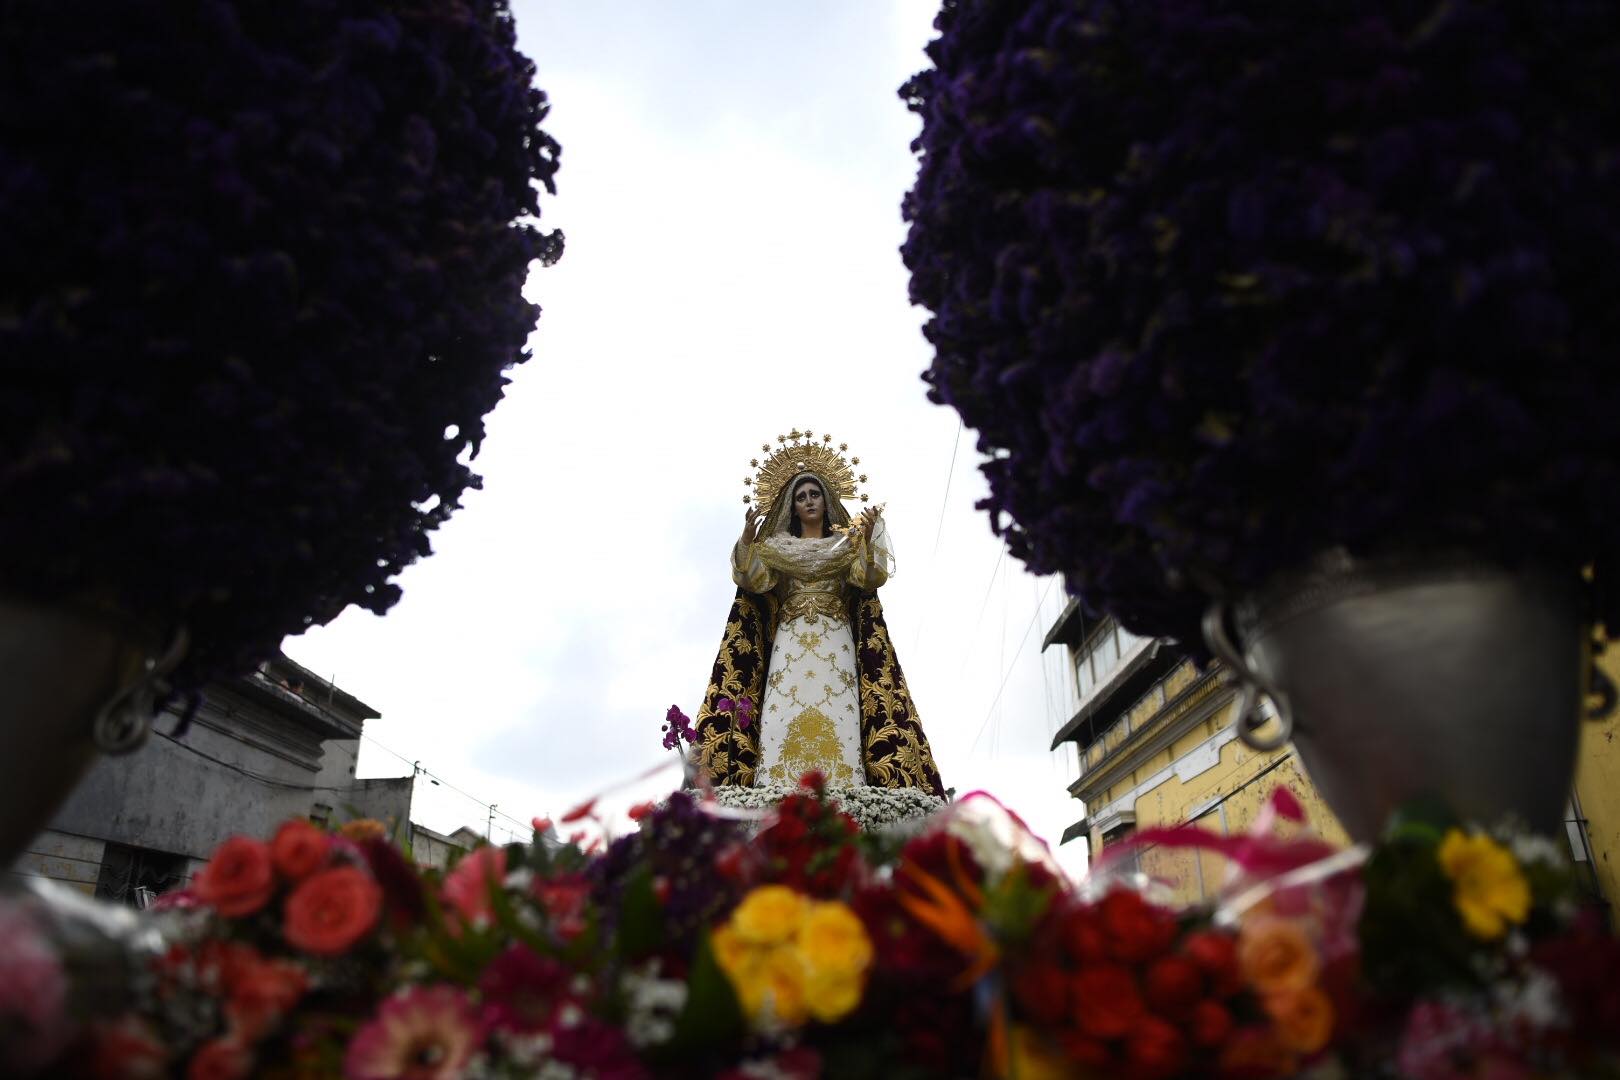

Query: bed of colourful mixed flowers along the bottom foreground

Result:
[0,777,1620,1080]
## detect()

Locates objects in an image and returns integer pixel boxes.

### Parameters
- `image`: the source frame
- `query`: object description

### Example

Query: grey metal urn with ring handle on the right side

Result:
[1204,552,1594,840]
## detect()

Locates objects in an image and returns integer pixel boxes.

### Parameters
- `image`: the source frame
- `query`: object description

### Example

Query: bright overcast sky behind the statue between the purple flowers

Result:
[285,0,1084,866]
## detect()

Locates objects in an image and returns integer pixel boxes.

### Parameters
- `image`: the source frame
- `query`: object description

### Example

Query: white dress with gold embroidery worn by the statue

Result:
[732,518,893,787]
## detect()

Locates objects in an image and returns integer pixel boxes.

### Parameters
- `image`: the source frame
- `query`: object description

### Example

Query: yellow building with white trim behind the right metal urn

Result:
[1043,601,1620,907]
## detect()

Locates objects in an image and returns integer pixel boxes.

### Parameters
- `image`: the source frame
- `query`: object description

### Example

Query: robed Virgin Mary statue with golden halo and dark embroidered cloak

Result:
[695,431,944,797]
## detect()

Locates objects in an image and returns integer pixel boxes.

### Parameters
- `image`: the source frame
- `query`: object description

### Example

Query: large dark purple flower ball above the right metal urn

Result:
[902,0,1620,643]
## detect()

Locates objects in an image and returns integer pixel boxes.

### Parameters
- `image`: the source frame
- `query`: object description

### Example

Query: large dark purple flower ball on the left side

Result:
[0,0,562,687]
